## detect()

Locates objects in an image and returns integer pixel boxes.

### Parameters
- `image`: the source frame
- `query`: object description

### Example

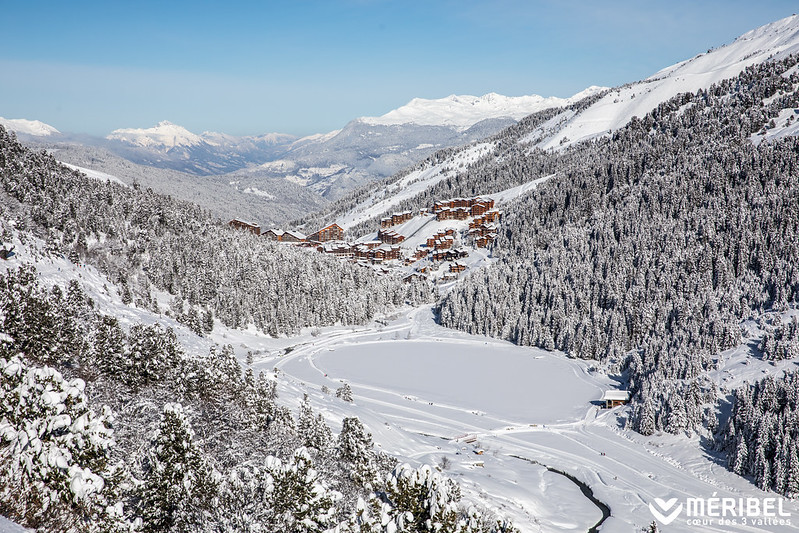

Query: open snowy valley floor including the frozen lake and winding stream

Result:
[6,216,799,533]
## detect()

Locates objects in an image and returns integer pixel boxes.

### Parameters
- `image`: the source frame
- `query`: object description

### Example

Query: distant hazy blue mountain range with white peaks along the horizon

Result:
[0,87,600,206]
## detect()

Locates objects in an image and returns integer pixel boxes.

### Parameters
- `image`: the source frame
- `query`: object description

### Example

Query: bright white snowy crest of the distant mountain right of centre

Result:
[360,86,605,128]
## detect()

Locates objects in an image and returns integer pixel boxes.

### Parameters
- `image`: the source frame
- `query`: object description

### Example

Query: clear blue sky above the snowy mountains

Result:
[0,0,797,135]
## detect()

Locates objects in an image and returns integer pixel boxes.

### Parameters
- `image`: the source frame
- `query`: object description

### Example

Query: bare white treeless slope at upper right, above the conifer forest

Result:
[539,15,799,149]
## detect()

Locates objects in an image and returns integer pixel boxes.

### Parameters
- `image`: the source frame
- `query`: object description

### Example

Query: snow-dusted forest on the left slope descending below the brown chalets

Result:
[0,130,430,335]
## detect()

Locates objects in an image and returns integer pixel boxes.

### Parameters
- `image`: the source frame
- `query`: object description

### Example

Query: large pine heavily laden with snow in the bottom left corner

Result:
[0,357,127,532]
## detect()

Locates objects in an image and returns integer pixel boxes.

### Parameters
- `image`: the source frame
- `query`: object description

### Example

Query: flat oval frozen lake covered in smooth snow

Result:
[314,340,602,423]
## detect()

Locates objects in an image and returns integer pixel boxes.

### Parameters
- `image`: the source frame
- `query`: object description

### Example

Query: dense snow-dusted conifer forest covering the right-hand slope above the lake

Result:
[439,57,799,487]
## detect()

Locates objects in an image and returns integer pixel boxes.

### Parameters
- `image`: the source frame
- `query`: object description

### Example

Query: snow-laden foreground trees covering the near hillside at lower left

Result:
[0,250,515,533]
